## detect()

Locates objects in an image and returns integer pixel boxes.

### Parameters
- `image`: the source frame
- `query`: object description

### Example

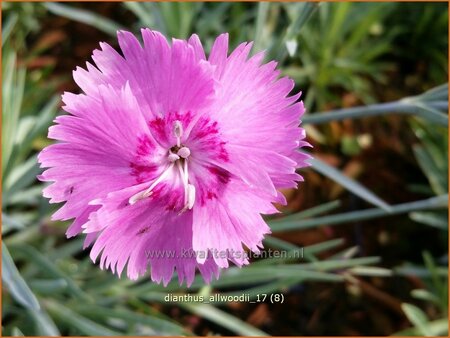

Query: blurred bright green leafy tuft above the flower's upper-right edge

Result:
[285,2,397,110]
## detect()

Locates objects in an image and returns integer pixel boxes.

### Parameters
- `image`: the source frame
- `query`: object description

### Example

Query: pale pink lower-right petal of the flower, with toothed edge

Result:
[192,180,272,268]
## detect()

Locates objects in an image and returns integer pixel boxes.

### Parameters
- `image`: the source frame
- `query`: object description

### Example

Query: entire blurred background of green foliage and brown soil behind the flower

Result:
[2,2,448,335]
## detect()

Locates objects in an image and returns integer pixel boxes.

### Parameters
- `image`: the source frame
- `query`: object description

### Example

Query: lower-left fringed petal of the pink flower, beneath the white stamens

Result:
[88,185,218,285]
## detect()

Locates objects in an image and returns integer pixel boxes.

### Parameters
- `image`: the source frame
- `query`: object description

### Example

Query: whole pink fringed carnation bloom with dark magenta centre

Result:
[39,29,308,285]
